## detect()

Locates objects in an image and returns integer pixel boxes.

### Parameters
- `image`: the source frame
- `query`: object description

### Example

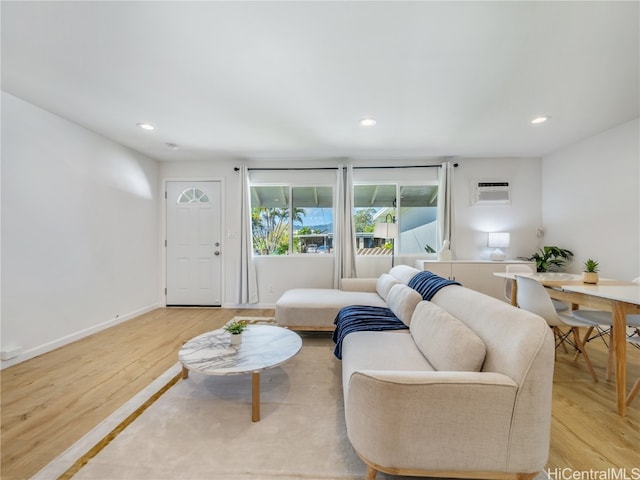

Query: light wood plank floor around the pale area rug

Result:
[0,308,640,480]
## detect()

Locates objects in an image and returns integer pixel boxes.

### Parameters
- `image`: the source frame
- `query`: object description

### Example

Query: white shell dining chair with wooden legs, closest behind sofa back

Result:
[516,275,598,382]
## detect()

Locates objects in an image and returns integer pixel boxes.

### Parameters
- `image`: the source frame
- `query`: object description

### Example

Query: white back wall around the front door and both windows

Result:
[159,158,542,307]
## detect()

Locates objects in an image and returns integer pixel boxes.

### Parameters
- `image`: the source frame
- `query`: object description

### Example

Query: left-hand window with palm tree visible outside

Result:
[251,185,333,255]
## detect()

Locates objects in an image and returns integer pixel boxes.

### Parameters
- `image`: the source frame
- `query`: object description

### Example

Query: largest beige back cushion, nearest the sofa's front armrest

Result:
[409,301,486,372]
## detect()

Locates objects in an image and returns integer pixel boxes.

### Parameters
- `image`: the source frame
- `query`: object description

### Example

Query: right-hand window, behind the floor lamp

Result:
[353,184,438,255]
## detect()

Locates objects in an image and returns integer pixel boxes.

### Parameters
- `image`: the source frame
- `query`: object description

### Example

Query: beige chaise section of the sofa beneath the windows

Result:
[275,265,420,331]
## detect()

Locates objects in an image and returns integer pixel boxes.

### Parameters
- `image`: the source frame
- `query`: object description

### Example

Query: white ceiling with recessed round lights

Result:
[1,1,640,160]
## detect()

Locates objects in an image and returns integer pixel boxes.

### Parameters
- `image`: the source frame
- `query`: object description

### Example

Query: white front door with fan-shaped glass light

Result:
[166,181,222,306]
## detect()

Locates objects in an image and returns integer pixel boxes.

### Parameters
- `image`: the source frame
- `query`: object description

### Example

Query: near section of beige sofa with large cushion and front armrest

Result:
[342,286,554,480]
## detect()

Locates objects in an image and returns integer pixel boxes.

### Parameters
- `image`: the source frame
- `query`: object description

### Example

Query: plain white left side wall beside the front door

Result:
[1,92,159,368]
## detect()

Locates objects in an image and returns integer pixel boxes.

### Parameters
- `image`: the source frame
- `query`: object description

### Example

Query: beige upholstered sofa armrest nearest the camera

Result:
[345,370,549,472]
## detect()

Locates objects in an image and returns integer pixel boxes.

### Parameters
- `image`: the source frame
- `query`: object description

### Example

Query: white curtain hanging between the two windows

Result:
[333,165,358,288]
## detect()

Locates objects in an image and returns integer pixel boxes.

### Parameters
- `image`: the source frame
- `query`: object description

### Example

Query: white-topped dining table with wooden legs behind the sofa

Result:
[494,272,640,416]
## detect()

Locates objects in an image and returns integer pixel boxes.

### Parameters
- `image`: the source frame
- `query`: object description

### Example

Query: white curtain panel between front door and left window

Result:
[237,166,259,304]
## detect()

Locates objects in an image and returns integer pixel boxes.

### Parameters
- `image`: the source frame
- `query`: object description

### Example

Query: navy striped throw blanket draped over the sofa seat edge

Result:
[333,305,409,360]
